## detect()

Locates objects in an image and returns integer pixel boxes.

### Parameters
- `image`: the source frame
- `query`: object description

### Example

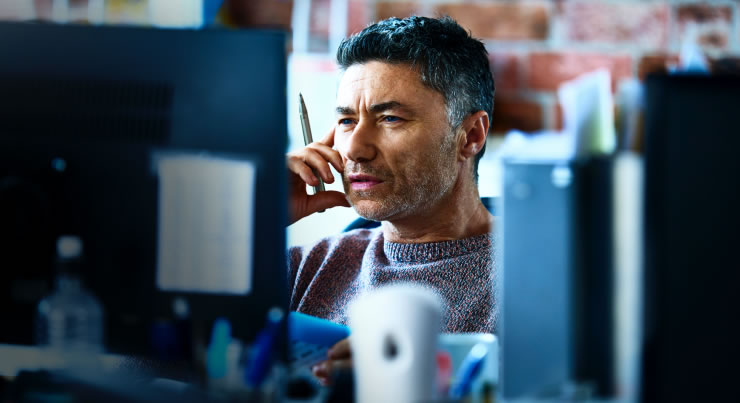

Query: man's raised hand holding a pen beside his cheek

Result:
[288,128,350,224]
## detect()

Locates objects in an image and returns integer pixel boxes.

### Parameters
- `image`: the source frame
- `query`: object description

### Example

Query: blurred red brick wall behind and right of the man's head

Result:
[298,0,740,133]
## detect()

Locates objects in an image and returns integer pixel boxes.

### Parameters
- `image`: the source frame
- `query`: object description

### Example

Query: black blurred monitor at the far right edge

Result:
[642,75,740,402]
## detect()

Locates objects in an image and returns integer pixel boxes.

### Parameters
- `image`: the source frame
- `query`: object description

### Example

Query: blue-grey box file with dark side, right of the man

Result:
[498,158,614,398]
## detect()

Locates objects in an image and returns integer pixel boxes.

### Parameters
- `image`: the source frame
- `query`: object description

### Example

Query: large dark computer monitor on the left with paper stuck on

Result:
[0,23,288,355]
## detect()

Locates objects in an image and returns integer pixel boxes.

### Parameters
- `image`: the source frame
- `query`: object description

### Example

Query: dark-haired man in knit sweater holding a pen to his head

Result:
[288,17,497,384]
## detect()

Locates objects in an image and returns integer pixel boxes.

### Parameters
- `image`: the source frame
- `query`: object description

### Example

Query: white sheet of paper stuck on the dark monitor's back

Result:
[156,154,256,294]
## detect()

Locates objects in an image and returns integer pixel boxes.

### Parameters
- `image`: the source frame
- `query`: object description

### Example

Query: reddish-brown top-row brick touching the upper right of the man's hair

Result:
[435,2,550,40]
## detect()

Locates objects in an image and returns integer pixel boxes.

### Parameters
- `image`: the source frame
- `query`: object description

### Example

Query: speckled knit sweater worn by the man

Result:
[288,228,498,333]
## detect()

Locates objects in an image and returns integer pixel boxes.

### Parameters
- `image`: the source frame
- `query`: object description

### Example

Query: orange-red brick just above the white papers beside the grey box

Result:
[527,52,632,91]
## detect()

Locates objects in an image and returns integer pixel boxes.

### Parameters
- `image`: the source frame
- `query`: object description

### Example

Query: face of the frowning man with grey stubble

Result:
[334,62,458,221]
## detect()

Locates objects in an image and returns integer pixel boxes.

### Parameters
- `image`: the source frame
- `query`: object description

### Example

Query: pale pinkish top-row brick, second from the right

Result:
[563,1,670,48]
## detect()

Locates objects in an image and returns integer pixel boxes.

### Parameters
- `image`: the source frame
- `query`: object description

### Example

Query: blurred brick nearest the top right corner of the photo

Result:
[673,3,733,49]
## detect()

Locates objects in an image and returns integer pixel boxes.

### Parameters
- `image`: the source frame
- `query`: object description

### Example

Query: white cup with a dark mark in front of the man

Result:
[349,284,442,403]
